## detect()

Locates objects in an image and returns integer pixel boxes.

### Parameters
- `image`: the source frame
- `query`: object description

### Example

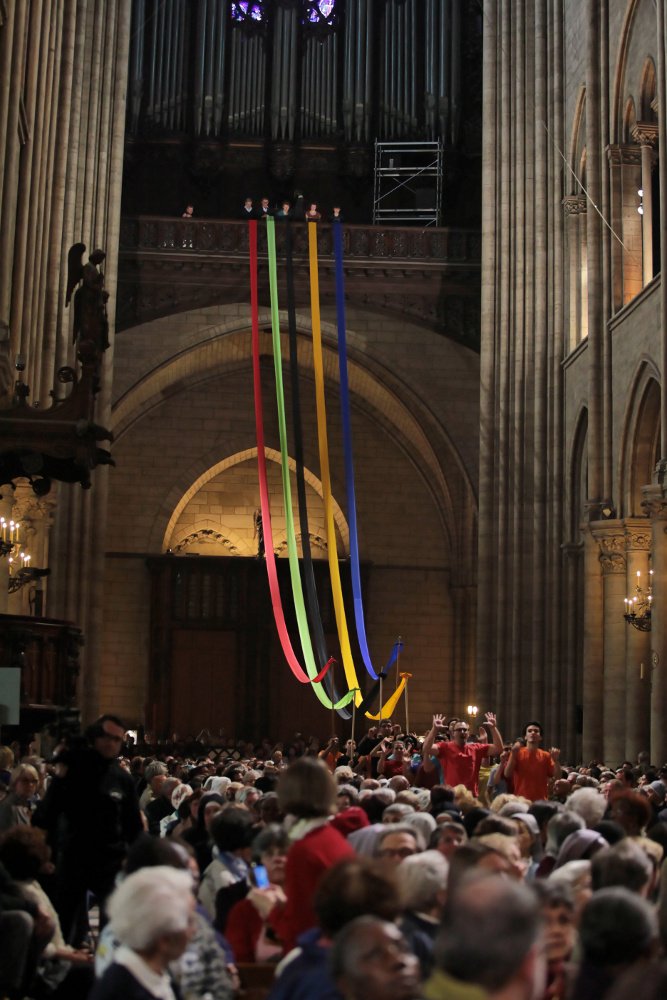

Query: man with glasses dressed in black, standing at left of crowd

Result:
[33,715,143,946]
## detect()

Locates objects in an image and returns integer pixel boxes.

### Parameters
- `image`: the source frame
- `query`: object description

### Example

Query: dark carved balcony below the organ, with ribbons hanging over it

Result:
[116,216,481,348]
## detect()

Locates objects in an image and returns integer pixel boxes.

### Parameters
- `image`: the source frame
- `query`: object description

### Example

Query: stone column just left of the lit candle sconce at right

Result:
[591,521,627,766]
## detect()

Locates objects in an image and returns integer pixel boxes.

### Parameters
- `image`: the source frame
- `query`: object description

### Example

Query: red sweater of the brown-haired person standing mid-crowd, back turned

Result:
[269,823,355,954]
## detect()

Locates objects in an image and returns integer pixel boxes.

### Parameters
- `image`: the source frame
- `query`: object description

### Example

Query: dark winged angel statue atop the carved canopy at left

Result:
[65,243,109,351]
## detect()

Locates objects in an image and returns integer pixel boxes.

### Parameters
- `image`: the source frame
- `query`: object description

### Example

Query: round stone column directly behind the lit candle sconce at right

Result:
[618,517,651,760]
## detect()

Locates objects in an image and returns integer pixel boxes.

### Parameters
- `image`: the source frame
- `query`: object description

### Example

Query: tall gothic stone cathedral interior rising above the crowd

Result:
[0,0,667,764]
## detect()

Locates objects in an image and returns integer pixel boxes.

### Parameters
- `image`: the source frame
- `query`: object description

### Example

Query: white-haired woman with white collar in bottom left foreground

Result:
[89,865,195,1000]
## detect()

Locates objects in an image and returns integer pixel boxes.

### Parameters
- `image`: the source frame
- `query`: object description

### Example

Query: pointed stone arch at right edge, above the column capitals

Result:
[619,357,661,517]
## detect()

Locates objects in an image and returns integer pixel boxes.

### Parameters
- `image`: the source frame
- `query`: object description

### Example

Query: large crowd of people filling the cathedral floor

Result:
[0,712,667,1000]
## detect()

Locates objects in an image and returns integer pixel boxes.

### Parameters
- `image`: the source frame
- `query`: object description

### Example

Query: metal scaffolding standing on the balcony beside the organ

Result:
[373,139,443,226]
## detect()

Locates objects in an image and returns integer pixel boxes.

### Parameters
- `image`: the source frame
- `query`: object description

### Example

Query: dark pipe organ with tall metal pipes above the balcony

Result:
[127,0,464,145]
